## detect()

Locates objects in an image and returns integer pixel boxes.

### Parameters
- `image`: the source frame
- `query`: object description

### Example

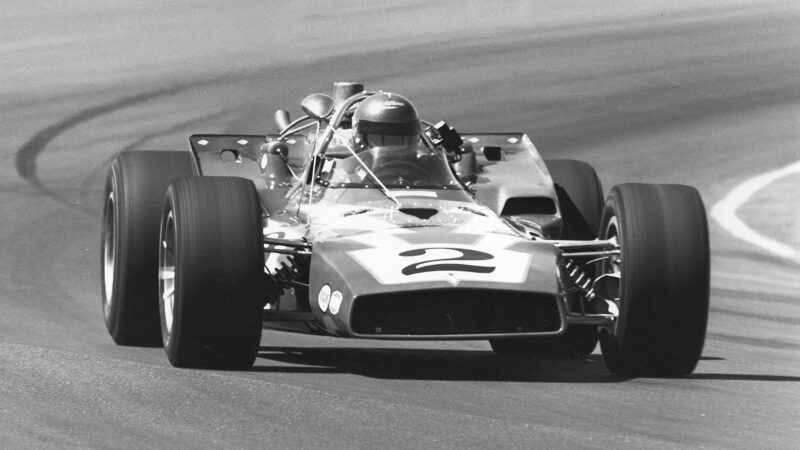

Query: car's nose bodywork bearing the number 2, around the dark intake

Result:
[309,228,563,339]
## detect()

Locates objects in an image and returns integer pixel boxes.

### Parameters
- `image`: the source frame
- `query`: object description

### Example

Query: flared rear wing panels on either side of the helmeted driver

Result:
[189,133,561,230]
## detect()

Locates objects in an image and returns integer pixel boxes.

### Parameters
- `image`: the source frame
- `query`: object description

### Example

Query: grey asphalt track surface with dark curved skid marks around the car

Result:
[0,0,800,448]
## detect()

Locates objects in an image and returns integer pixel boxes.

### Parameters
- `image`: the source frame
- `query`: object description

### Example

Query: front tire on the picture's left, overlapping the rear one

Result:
[158,177,266,369]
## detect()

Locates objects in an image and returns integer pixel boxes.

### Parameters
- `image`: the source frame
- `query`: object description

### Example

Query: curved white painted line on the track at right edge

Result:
[711,161,800,263]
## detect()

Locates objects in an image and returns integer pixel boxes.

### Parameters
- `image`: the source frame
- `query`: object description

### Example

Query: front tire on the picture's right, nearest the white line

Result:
[600,184,710,377]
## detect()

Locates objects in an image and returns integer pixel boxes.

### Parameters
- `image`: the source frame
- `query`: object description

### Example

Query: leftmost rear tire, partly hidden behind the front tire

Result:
[100,151,197,346]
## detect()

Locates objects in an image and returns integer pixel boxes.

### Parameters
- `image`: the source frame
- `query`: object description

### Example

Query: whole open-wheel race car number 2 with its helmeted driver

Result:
[101,83,710,376]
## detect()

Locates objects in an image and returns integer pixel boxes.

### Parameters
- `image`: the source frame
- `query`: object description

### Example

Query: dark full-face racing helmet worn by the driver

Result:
[353,92,420,149]
